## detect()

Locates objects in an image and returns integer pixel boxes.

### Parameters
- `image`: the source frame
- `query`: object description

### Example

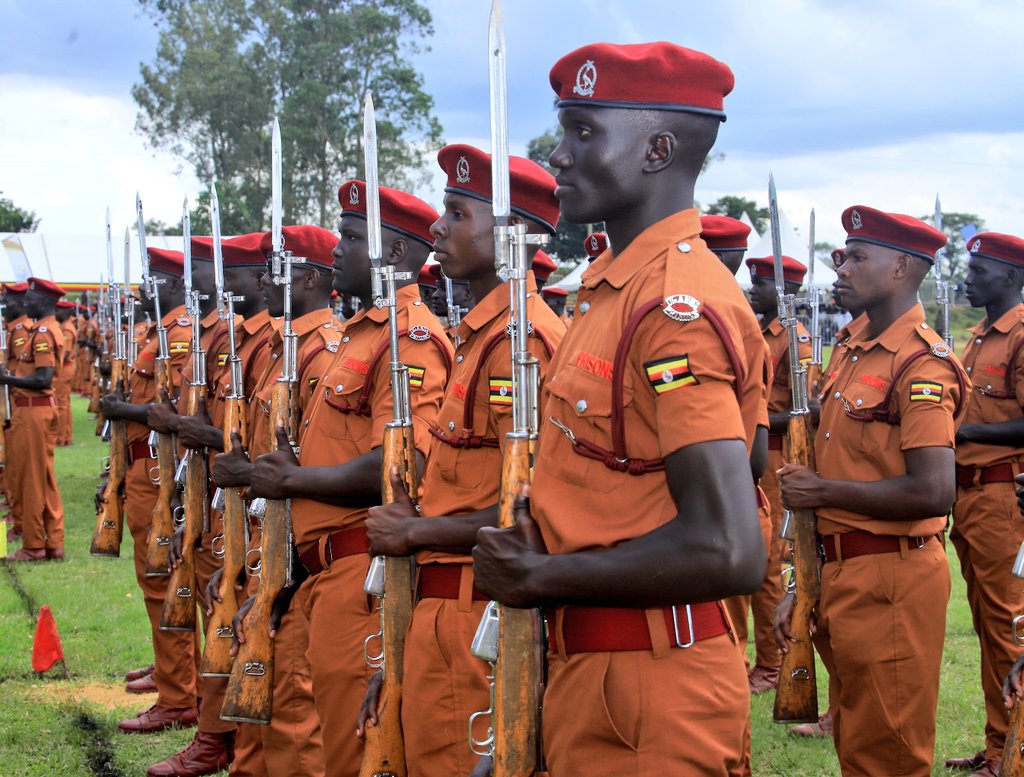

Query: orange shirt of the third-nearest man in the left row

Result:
[292,284,452,547]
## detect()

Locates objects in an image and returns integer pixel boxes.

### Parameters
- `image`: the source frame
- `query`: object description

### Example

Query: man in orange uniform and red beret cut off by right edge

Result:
[946,232,1024,777]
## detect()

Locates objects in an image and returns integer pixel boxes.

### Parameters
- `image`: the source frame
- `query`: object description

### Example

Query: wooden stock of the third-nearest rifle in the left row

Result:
[220,380,295,725]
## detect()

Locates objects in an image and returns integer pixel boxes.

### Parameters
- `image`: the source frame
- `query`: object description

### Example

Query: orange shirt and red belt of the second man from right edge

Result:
[814,304,970,536]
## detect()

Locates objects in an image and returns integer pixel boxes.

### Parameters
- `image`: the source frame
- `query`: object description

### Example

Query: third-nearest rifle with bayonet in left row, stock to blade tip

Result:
[220,119,305,724]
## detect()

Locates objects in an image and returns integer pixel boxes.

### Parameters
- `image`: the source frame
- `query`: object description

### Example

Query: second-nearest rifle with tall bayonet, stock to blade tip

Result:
[359,91,419,777]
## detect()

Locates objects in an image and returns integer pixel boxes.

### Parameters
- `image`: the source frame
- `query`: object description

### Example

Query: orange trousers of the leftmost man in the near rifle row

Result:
[125,459,199,709]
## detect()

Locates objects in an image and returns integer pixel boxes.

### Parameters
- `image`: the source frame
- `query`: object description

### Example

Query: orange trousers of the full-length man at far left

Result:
[6,405,63,550]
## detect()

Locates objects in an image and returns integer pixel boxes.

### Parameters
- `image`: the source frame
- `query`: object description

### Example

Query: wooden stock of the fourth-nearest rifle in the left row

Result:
[199,396,249,677]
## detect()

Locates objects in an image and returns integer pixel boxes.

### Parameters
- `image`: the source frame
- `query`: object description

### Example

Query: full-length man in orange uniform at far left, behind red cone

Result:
[0,277,66,561]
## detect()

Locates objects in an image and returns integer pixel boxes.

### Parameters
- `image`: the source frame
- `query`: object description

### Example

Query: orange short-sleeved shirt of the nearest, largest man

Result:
[532,210,769,553]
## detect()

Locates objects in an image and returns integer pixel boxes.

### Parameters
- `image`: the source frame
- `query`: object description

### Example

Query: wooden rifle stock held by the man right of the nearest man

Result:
[773,413,821,723]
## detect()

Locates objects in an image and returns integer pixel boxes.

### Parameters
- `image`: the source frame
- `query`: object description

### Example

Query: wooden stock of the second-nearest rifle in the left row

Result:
[359,425,420,777]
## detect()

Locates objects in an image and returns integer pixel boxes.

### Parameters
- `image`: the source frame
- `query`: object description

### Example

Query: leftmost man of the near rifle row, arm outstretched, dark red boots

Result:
[100,248,198,734]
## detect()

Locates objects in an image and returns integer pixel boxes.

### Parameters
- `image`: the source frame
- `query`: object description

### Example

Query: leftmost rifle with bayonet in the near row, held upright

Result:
[89,209,131,558]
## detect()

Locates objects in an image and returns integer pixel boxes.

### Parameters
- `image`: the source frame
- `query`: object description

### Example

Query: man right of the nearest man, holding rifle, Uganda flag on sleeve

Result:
[775,205,970,775]
